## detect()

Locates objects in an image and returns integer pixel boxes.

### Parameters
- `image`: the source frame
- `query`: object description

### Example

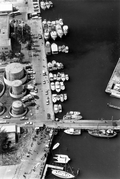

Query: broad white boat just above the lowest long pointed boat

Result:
[53,154,70,163]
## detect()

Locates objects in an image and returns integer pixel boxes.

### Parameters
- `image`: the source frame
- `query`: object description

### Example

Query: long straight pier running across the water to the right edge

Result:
[31,119,120,130]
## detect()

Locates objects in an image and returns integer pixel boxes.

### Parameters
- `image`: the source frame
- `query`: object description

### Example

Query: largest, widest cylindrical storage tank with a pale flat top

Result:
[5,63,24,81]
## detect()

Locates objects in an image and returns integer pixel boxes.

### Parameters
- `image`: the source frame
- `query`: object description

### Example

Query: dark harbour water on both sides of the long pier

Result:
[42,0,120,179]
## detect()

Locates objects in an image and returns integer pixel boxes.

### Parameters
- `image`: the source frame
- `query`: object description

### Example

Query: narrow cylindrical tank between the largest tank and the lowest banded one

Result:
[12,80,23,95]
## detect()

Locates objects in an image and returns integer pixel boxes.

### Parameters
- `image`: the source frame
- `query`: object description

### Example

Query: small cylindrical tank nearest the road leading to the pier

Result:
[12,101,25,115]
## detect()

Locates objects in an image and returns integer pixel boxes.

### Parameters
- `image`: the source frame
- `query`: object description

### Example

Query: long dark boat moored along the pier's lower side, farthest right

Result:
[88,129,117,138]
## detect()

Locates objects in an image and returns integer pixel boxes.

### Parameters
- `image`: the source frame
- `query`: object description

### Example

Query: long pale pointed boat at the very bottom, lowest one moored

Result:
[52,169,75,178]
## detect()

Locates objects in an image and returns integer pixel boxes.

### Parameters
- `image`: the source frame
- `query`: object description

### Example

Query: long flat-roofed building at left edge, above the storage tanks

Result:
[0,14,11,55]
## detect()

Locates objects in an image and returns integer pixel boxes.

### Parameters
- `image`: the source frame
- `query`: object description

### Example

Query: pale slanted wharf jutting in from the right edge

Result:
[105,58,120,93]
